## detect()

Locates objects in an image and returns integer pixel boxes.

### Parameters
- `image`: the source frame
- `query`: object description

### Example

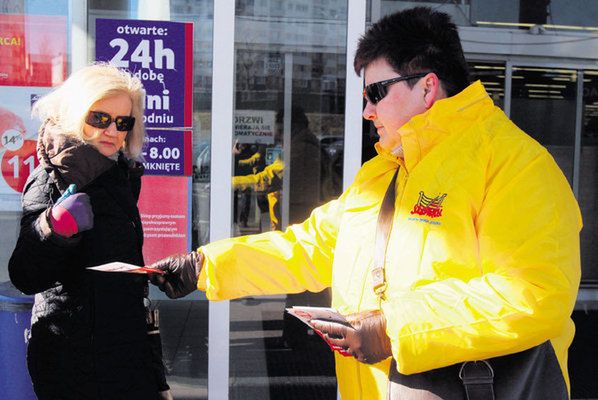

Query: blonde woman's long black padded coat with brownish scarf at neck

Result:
[9,122,158,400]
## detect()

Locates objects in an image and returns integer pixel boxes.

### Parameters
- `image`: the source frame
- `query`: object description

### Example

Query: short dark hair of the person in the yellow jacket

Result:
[353,7,469,96]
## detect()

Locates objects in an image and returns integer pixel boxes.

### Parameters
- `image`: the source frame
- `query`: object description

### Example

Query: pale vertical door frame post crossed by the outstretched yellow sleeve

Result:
[208,0,235,399]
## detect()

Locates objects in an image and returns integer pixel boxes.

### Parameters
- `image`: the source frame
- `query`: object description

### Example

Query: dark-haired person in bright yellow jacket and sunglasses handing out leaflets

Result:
[153,8,581,400]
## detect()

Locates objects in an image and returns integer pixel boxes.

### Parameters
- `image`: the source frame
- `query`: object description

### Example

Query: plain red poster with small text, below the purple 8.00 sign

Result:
[139,175,191,265]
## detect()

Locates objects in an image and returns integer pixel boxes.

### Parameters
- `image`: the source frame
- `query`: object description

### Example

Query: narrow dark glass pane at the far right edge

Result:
[579,71,598,283]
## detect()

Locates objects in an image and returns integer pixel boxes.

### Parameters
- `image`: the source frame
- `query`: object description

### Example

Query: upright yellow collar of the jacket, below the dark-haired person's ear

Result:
[375,81,494,171]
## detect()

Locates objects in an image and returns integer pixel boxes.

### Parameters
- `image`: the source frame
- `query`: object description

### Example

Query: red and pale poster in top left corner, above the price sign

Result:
[0,14,67,86]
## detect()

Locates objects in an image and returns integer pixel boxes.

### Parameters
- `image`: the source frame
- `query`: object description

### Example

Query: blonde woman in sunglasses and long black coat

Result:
[9,64,171,400]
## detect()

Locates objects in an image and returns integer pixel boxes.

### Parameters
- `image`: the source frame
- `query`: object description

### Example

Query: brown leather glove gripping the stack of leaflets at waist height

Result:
[311,310,392,364]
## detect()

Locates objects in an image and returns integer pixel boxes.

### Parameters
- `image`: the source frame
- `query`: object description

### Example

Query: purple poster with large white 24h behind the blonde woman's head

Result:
[96,19,193,128]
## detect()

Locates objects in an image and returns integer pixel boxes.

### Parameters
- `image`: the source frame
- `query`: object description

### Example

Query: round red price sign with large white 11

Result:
[2,140,39,193]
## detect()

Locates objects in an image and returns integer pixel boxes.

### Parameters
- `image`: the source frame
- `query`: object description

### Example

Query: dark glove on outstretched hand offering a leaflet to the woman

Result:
[148,251,203,299]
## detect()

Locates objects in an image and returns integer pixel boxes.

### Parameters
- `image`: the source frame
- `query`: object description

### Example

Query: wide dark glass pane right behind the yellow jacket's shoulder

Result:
[511,67,577,183]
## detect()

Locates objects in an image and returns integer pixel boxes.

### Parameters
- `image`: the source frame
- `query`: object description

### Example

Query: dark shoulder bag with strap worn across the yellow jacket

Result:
[371,169,569,400]
